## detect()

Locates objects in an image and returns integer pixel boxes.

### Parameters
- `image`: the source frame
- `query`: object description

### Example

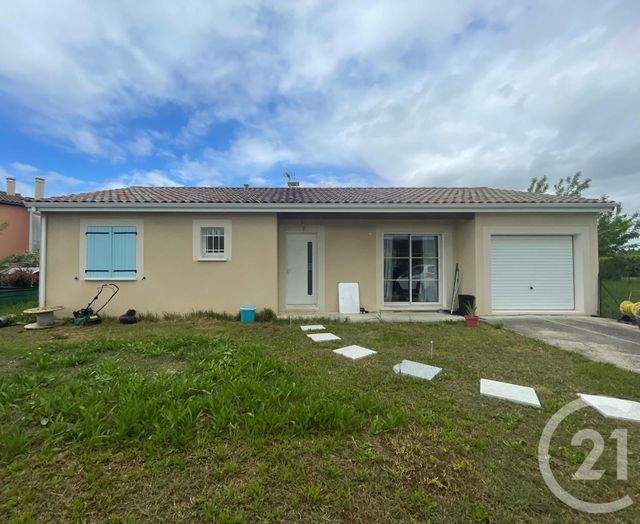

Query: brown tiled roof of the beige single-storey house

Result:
[36,186,600,205]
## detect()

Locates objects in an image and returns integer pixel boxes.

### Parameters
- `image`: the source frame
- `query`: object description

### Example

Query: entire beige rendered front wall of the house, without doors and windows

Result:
[46,209,598,315]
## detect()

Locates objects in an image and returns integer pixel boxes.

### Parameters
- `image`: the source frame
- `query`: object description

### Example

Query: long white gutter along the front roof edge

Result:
[26,202,615,213]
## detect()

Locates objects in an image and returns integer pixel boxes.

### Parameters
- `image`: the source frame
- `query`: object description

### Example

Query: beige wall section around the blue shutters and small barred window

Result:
[46,213,278,316]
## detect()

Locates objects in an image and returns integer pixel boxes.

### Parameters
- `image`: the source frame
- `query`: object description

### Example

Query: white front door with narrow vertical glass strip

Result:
[287,233,317,306]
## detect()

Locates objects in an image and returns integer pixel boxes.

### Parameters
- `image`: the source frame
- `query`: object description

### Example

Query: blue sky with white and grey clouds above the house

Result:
[0,0,640,209]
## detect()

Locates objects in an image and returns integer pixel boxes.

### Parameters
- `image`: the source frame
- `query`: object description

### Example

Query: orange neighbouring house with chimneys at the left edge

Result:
[0,177,44,259]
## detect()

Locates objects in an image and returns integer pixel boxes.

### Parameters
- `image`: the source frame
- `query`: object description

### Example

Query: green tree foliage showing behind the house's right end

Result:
[527,171,640,256]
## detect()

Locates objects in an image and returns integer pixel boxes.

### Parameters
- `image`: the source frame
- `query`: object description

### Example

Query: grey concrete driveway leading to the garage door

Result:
[486,315,640,373]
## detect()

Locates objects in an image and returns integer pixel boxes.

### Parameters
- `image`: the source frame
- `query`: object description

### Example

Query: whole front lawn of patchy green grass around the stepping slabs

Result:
[0,315,640,522]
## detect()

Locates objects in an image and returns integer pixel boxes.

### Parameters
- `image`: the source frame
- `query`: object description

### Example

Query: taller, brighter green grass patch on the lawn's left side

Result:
[0,335,400,458]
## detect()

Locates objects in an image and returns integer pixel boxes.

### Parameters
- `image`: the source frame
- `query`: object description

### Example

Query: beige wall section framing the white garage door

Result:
[476,213,598,315]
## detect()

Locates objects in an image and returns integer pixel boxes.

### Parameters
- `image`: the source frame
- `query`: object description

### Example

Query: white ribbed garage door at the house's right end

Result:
[491,235,574,311]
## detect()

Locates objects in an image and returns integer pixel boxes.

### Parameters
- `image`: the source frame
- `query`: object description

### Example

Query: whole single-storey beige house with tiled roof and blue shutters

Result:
[29,187,612,314]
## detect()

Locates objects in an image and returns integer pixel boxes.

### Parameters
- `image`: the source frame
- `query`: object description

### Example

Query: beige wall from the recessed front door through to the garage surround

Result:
[279,213,598,315]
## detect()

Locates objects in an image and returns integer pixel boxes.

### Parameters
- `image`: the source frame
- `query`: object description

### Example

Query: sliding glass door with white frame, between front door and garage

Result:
[384,235,440,304]
